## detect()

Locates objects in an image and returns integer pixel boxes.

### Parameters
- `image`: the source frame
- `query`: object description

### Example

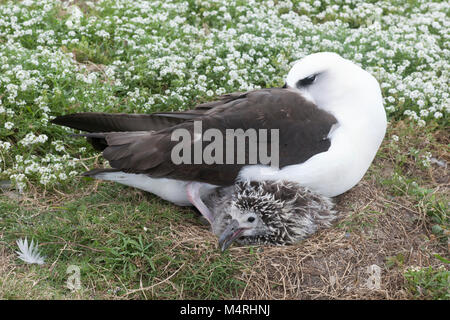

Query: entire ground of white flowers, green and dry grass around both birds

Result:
[0,0,450,300]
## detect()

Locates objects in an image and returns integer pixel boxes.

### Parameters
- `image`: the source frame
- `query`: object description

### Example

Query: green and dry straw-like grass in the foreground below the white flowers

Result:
[0,122,448,299]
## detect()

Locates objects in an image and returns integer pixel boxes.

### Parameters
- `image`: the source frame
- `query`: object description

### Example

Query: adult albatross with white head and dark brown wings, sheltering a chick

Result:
[52,52,386,248]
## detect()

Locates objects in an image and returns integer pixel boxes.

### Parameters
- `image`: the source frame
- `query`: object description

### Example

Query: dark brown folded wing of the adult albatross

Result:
[52,88,336,185]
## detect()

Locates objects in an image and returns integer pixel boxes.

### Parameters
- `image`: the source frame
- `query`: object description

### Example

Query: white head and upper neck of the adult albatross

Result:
[286,52,386,129]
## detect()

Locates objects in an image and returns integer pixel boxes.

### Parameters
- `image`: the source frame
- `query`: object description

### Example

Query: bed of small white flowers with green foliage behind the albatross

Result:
[0,0,450,188]
